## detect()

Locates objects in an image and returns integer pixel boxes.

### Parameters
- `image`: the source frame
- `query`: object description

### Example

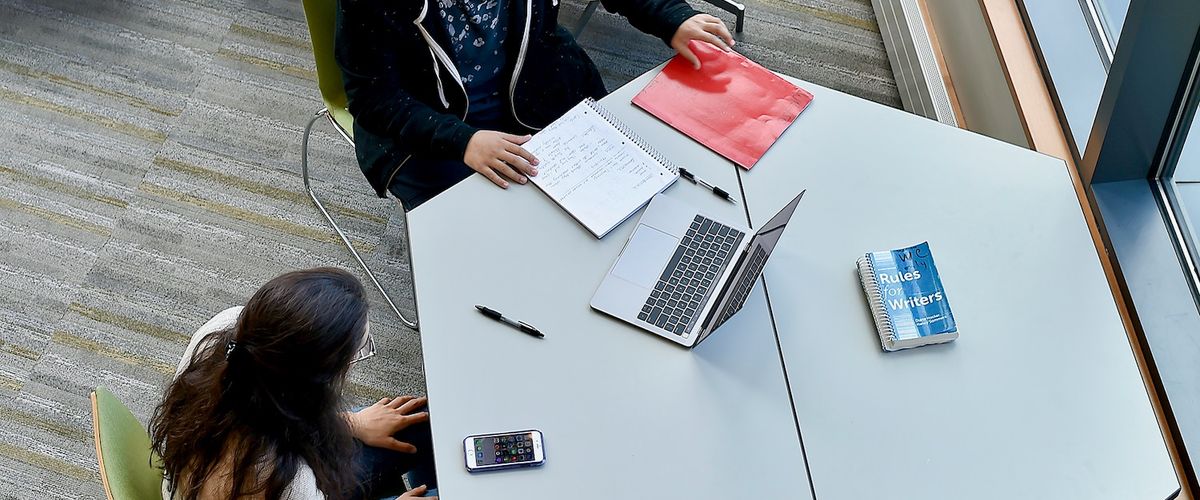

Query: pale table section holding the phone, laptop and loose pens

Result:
[408,71,810,500]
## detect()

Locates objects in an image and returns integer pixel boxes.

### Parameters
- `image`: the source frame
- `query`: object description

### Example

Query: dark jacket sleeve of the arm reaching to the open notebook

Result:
[335,0,478,159]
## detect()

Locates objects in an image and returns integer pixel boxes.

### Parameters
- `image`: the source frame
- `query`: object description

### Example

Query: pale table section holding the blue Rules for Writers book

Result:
[740,76,1178,500]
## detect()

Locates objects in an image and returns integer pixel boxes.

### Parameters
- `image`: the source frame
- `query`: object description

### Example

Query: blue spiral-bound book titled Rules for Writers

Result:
[858,242,959,351]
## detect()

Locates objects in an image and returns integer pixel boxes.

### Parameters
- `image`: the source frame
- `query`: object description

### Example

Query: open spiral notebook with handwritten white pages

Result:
[523,98,679,237]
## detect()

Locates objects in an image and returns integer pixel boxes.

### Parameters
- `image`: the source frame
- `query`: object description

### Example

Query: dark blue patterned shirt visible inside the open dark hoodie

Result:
[438,0,509,125]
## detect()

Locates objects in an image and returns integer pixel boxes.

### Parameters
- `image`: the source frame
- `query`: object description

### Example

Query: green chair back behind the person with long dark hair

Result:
[91,387,162,500]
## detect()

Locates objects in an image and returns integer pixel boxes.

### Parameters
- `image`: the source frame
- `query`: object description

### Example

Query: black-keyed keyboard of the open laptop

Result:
[637,216,745,335]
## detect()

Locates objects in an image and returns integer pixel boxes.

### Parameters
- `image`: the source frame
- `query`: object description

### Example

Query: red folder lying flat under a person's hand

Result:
[634,41,812,170]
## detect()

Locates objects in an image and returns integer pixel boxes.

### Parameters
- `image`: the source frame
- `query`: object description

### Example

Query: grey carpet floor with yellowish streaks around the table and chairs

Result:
[0,0,899,498]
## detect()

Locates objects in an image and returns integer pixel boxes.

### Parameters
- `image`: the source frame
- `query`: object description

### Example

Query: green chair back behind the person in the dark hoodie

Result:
[304,0,354,138]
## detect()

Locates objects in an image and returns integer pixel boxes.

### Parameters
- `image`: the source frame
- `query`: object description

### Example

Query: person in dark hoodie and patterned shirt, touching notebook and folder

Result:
[336,0,733,210]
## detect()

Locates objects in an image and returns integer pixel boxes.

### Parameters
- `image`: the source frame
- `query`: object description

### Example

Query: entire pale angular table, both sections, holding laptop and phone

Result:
[409,61,1178,499]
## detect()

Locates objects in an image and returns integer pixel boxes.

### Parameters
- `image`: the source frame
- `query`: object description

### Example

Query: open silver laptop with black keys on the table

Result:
[592,191,804,348]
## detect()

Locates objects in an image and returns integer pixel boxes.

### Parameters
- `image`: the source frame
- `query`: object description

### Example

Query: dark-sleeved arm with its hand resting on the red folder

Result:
[600,0,733,70]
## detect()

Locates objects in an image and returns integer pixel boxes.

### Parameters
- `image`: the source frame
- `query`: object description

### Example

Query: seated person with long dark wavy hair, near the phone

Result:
[150,267,433,500]
